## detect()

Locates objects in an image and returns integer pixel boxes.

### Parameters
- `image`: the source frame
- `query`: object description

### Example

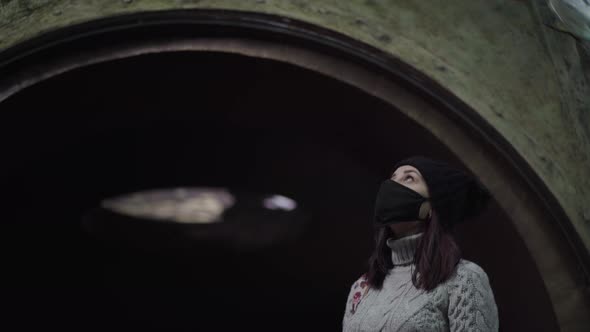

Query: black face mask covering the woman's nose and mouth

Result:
[375,179,428,226]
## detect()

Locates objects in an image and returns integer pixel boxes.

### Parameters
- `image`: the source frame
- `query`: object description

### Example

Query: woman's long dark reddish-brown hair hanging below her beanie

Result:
[367,211,461,291]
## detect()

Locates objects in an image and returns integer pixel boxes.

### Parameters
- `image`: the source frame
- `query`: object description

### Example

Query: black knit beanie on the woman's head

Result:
[393,156,491,228]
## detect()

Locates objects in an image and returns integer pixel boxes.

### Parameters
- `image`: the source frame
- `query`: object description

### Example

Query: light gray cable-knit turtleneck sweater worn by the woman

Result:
[342,234,498,332]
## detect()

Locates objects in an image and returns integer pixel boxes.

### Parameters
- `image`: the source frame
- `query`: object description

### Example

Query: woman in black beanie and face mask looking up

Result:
[343,156,499,331]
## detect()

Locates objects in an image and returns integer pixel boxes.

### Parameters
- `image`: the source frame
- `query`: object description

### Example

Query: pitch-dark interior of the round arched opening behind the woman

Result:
[0,52,557,331]
